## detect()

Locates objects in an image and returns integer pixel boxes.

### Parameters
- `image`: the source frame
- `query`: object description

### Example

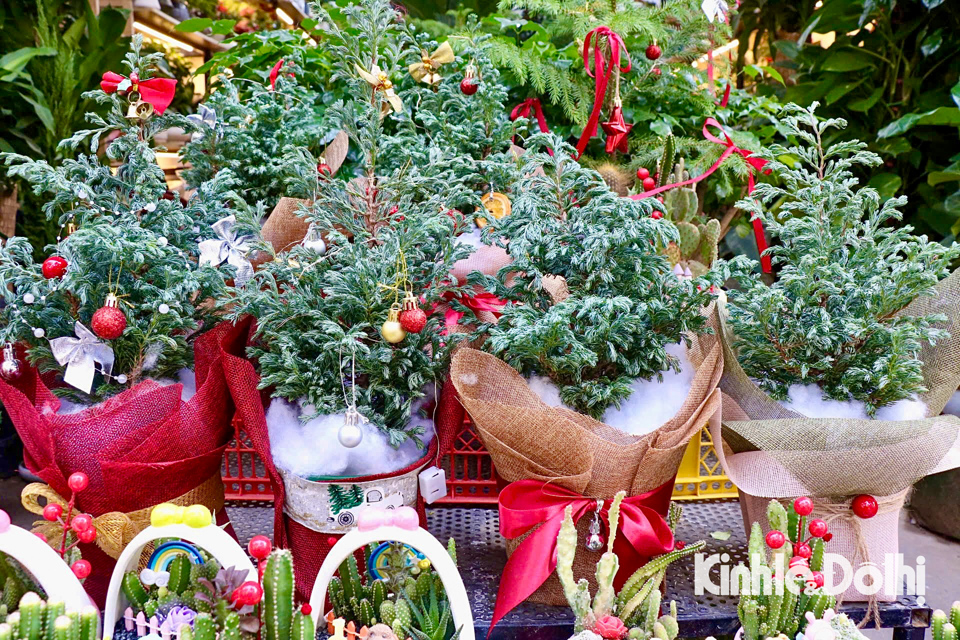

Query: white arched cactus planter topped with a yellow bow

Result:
[104,503,263,640]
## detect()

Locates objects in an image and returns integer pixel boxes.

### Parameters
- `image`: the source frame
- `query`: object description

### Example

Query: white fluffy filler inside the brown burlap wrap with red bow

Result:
[527,344,696,435]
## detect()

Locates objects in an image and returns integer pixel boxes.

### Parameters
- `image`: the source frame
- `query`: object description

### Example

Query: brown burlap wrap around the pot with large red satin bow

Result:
[450,304,723,605]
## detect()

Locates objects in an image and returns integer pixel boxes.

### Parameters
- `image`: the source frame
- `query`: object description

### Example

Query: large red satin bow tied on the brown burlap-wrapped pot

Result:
[487,480,673,637]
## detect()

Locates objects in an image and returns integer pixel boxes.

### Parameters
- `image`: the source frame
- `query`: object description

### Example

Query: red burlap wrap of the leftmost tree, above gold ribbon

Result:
[0,325,239,606]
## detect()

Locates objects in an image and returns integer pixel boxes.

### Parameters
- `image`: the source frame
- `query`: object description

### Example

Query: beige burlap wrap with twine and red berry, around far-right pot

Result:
[711,272,960,605]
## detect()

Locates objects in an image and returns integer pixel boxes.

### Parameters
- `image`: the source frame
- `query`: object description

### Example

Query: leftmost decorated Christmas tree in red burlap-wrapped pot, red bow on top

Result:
[0,36,249,602]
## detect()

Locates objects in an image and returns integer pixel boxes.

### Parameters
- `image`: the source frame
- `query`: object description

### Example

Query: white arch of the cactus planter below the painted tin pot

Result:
[310,525,476,640]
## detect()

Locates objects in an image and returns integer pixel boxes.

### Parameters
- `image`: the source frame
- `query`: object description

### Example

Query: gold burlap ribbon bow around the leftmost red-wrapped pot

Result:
[20,474,224,558]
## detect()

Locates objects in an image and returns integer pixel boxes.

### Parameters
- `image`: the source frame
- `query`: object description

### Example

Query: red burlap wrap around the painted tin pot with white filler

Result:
[220,317,463,600]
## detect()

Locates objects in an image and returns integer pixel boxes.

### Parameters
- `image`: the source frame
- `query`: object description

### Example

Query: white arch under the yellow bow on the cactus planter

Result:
[103,523,259,640]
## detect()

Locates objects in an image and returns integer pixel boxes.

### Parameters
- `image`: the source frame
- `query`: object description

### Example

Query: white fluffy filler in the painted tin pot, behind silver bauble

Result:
[267,387,436,478]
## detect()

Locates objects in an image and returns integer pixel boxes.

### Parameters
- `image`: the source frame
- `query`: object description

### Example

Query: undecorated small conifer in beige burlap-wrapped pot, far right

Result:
[711,105,960,603]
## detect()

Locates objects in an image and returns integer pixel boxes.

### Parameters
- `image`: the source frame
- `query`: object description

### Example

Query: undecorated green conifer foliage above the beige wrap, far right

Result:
[729,103,960,415]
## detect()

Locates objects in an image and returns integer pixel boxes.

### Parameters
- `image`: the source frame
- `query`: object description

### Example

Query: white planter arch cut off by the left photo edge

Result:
[0,525,100,624]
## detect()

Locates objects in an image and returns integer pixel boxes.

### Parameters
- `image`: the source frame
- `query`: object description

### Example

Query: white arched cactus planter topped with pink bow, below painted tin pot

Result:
[310,507,474,640]
